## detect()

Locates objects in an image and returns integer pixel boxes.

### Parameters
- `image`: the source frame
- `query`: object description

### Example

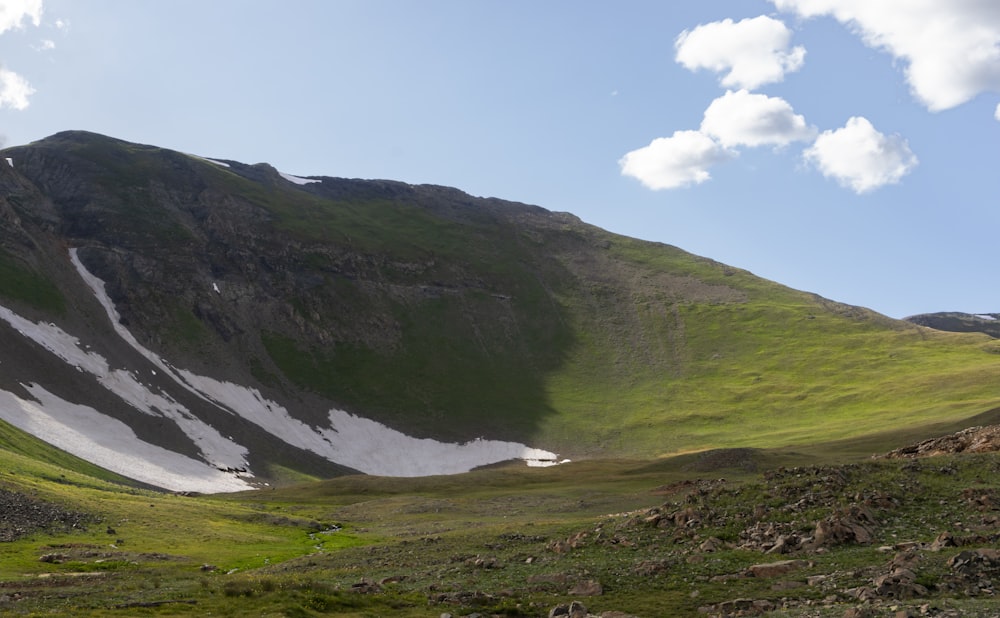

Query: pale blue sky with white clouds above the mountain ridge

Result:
[0,0,1000,318]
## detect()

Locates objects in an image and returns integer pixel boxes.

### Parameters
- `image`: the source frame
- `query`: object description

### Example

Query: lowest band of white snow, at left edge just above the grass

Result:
[0,384,254,493]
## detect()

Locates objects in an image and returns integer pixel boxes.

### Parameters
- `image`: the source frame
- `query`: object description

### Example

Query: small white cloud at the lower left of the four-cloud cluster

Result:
[618,131,735,189]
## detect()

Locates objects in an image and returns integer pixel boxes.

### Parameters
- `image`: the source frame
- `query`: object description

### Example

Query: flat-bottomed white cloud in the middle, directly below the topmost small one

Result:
[701,90,816,148]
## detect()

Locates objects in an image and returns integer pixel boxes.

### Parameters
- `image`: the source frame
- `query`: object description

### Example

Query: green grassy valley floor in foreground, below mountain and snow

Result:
[0,430,1000,617]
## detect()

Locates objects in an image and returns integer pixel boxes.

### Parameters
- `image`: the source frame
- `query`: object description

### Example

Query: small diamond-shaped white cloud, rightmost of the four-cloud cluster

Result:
[804,116,917,194]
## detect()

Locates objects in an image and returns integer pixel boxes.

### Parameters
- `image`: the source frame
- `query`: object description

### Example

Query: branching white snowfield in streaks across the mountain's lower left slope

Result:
[0,249,558,493]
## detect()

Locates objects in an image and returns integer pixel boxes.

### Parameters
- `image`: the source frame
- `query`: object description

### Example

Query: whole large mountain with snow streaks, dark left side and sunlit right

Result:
[0,131,1000,491]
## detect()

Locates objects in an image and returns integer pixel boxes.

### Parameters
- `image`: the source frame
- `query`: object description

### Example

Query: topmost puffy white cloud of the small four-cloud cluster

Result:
[674,15,806,90]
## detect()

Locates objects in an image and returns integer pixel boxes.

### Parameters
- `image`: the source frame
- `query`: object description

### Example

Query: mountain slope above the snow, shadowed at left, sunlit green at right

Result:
[0,132,1000,470]
